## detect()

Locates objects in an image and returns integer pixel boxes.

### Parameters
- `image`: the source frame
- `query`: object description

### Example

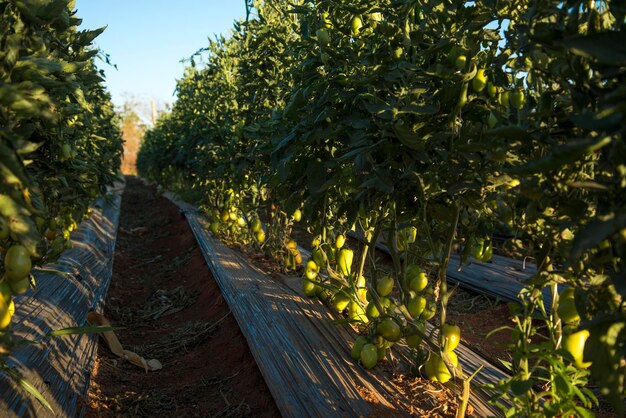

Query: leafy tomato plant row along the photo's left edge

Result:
[0,0,122,404]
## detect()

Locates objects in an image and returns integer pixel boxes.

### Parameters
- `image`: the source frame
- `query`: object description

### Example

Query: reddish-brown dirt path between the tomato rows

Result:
[86,177,279,417]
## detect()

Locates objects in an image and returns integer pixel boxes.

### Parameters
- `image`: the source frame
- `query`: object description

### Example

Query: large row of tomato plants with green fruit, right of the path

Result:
[138,0,626,416]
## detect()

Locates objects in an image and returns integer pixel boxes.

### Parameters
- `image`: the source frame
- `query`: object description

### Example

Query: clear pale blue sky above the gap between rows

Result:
[76,0,246,107]
